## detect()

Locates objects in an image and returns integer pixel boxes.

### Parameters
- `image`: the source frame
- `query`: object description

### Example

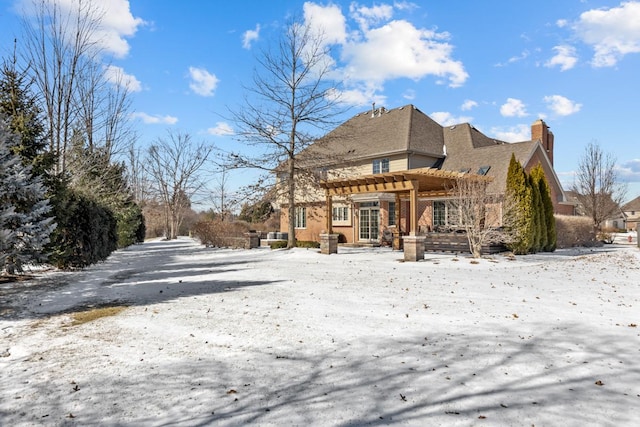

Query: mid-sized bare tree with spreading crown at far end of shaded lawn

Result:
[145,131,213,239]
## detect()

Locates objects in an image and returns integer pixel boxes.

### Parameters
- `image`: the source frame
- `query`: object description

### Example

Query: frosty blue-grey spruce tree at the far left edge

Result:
[0,117,55,274]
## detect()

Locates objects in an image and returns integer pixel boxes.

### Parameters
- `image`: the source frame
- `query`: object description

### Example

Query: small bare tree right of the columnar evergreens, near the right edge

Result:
[571,142,626,231]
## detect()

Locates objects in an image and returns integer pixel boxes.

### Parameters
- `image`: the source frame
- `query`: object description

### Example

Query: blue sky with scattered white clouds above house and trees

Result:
[0,0,640,207]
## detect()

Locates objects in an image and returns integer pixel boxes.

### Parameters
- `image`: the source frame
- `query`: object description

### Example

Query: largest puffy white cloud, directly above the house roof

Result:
[304,1,469,105]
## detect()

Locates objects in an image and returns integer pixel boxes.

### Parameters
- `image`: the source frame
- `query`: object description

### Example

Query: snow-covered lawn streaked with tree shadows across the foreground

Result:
[0,239,640,426]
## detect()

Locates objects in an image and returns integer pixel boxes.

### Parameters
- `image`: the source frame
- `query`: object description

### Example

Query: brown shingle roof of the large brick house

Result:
[306,104,541,193]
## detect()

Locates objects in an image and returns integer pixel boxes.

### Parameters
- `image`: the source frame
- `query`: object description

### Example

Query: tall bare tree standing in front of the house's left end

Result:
[231,19,337,248]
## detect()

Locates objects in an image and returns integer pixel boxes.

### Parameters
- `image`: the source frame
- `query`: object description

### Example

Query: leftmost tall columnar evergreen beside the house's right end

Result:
[503,154,533,254]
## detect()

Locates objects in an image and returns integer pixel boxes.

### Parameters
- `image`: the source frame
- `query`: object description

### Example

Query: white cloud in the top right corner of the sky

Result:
[573,1,640,67]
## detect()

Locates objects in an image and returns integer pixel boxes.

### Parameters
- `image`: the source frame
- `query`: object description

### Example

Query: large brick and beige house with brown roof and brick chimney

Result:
[281,105,574,243]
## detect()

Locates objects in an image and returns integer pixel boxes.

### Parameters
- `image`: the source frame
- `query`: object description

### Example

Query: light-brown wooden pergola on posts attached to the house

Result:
[320,168,490,236]
